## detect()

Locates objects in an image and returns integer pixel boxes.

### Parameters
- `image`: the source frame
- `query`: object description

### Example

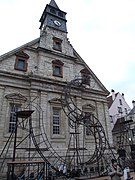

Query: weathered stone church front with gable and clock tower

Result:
[0,0,112,177]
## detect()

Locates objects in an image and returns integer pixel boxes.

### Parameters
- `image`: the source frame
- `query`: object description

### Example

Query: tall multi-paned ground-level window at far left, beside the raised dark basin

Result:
[9,104,21,133]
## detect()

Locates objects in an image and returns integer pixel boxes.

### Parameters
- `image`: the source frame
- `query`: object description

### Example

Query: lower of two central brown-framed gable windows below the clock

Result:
[52,60,64,77]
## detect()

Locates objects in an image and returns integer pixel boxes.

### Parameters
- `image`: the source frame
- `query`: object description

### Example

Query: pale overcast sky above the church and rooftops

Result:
[0,0,135,108]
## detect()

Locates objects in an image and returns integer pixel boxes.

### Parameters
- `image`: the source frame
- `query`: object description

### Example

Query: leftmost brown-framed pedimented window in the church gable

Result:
[15,51,29,71]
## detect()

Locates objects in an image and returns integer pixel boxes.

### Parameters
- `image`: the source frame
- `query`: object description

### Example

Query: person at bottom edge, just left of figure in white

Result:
[108,159,123,180]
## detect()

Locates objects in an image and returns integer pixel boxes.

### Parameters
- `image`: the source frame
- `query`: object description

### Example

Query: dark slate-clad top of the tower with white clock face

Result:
[40,0,67,32]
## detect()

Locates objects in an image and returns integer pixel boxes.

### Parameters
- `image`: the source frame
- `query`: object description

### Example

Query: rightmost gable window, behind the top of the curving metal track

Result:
[80,68,90,85]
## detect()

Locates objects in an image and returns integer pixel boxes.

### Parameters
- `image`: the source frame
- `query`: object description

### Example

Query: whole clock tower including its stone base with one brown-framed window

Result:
[39,0,74,57]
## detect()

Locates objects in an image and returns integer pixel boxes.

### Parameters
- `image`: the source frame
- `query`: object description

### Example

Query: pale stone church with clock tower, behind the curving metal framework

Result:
[0,0,112,177]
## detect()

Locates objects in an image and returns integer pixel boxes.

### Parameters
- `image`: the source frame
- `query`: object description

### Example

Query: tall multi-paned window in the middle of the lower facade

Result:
[53,108,60,134]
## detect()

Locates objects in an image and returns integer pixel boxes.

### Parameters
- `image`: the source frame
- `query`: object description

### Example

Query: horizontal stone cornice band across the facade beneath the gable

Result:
[0,71,107,98]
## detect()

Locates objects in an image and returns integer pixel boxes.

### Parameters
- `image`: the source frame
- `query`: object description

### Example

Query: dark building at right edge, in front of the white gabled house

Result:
[112,101,135,169]
